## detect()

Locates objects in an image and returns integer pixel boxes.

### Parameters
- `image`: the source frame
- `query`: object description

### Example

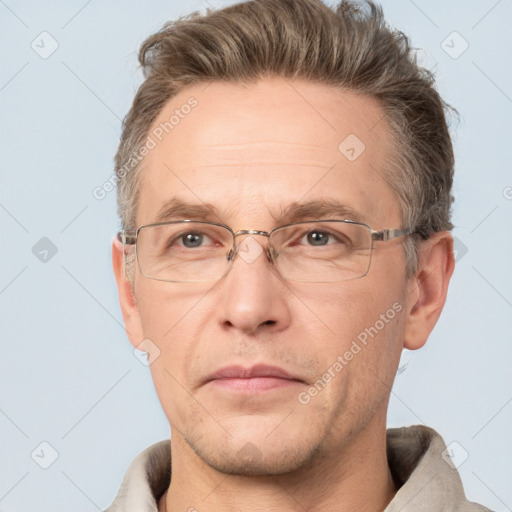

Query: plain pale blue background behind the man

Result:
[0,0,512,512]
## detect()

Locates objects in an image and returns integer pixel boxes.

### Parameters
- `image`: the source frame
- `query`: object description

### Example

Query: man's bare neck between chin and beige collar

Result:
[159,418,396,512]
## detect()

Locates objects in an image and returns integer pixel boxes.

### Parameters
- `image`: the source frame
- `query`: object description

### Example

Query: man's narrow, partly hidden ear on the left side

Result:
[112,237,144,347]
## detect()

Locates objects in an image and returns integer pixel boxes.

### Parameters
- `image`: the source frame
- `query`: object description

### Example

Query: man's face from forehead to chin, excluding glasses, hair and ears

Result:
[123,79,408,474]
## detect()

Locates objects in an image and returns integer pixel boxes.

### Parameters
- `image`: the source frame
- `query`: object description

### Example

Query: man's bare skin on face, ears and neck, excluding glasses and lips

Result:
[113,78,454,512]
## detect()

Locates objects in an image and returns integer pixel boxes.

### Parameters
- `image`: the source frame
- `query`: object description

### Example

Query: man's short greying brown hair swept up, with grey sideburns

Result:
[115,0,454,274]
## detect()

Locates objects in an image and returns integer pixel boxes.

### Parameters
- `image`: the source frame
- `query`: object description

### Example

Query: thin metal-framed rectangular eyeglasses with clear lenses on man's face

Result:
[117,220,414,283]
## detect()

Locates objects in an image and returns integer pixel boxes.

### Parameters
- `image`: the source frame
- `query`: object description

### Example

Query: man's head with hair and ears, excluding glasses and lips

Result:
[113,0,453,474]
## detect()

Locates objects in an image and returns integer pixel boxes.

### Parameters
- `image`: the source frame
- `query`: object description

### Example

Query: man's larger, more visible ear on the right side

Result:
[404,231,455,350]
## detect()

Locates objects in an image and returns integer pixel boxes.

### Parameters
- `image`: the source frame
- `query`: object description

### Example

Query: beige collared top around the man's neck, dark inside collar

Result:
[105,425,491,512]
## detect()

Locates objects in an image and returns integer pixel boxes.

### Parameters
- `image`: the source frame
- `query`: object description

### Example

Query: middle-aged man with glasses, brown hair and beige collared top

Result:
[108,0,487,512]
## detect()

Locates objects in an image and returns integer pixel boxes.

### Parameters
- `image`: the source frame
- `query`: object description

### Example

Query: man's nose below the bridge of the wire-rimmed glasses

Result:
[217,235,291,334]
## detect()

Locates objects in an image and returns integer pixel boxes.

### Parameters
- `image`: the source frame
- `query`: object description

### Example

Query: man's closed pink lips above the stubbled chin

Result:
[205,365,305,393]
